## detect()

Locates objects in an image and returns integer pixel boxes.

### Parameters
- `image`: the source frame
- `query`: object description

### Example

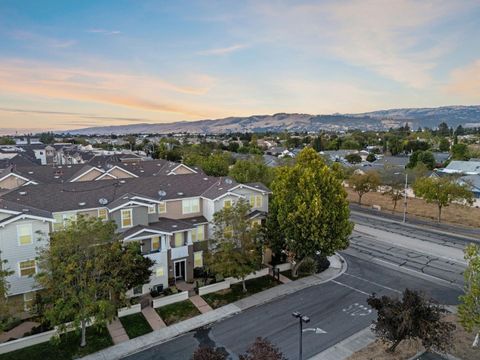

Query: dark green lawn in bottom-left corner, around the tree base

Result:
[0,327,113,360]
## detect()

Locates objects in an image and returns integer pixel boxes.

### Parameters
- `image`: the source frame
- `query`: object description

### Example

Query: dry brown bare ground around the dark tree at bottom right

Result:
[348,315,480,360]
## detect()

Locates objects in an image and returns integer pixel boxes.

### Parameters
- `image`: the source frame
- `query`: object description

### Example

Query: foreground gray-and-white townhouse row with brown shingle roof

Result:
[0,170,269,309]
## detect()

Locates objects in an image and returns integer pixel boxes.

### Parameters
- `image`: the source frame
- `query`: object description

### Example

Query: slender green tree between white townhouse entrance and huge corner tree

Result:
[205,200,261,292]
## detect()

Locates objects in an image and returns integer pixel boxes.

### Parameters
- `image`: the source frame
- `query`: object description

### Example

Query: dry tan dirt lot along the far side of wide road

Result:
[346,188,480,228]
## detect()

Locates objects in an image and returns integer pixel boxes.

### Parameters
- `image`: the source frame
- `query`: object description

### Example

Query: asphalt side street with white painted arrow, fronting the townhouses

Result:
[127,253,460,360]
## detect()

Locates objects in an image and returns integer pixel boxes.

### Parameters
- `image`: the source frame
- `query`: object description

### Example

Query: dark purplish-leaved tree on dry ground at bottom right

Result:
[367,289,455,352]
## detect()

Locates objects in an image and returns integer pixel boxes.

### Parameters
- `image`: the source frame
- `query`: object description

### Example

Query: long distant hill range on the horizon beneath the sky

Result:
[65,105,480,135]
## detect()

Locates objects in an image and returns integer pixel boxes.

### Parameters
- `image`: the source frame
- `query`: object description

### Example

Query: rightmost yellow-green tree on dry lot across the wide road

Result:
[413,177,473,222]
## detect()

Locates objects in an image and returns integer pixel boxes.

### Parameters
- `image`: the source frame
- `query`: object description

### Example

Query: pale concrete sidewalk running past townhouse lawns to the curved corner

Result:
[83,255,347,360]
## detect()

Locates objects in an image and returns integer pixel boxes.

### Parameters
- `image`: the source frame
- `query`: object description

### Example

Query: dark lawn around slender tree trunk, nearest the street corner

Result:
[202,276,280,309]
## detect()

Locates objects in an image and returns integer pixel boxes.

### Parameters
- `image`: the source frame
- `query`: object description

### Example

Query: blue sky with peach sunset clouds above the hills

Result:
[0,0,480,132]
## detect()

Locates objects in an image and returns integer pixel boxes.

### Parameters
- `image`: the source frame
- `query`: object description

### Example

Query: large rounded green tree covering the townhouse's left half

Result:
[36,216,153,347]
